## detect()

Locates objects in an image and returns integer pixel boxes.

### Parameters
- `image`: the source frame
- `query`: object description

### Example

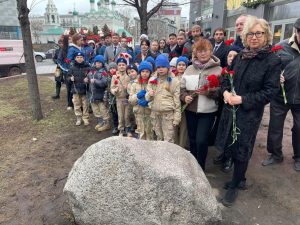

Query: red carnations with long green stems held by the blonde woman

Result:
[221,67,241,145]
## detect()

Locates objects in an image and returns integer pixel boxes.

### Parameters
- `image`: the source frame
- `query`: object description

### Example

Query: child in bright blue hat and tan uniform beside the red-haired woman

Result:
[145,55,181,143]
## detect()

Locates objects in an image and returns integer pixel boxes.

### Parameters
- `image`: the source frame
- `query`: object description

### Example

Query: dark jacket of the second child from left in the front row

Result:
[88,68,107,102]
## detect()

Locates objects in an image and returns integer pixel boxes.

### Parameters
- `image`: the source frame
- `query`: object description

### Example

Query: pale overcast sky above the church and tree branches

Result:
[27,0,189,17]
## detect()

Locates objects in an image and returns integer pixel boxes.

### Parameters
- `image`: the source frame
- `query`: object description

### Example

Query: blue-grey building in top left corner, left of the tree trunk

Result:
[0,0,22,39]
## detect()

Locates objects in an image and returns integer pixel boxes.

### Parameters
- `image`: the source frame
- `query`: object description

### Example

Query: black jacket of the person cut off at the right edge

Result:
[276,35,300,104]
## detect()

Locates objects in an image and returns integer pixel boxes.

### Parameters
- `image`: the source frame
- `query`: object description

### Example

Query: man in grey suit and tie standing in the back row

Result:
[104,33,126,65]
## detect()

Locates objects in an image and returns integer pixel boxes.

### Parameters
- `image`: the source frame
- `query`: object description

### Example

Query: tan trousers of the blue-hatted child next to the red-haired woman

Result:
[151,111,175,143]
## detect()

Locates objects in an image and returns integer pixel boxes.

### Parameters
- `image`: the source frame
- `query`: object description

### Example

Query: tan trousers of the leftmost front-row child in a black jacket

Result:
[72,94,89,121]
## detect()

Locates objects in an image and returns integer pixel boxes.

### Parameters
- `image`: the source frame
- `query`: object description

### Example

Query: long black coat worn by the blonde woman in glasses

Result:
[216,48,280,161]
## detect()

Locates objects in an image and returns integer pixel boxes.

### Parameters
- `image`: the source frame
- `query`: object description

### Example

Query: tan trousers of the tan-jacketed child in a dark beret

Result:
[117,98,131,131]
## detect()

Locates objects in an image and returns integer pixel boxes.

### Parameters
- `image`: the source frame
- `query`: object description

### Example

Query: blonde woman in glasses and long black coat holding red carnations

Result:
[216,16,280,206]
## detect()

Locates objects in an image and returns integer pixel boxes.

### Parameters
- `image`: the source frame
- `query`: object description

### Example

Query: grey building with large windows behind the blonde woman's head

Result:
[190,0,300,44]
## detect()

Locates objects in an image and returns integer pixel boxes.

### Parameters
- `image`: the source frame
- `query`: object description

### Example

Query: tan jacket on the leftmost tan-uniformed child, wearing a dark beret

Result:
[110,71,130,99]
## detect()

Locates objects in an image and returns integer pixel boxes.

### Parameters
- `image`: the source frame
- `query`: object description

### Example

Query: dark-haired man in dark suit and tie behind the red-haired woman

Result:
[213,27,230,67]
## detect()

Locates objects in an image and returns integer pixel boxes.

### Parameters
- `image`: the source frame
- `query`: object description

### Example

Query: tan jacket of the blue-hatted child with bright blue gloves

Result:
[129,79,151,115]
